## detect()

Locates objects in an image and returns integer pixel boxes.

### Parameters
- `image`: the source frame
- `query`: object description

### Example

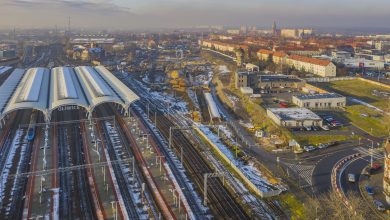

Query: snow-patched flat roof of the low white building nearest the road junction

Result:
[268,108,322,121]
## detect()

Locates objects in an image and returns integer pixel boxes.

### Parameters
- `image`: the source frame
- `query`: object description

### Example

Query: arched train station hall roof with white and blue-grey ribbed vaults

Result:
[0,66,139,121]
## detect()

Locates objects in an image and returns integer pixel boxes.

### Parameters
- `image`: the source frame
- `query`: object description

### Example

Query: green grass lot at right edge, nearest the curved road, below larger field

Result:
[345,105,390,137]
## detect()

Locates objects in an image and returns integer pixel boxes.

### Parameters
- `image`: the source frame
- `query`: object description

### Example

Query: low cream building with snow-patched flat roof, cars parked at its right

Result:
[267,108,322,128]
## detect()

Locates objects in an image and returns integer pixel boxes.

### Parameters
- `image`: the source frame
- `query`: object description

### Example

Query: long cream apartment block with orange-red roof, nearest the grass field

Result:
[287,55,336,77]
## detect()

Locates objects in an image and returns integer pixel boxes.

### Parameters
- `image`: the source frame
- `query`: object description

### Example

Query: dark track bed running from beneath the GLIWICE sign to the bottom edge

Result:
[56,113,97,219]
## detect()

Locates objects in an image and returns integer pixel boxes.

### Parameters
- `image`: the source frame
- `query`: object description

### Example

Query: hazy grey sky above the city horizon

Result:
[0,0,390,29]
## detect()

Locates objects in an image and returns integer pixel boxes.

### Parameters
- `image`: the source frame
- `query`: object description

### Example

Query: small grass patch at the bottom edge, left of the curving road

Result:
[279,193,305,220]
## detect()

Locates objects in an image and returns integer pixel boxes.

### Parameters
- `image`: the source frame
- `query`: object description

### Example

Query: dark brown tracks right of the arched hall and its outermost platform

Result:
[136,102,248,219]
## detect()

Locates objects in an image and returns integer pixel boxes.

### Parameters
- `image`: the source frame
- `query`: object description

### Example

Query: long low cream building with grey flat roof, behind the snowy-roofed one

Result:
[292,93,347,109]
